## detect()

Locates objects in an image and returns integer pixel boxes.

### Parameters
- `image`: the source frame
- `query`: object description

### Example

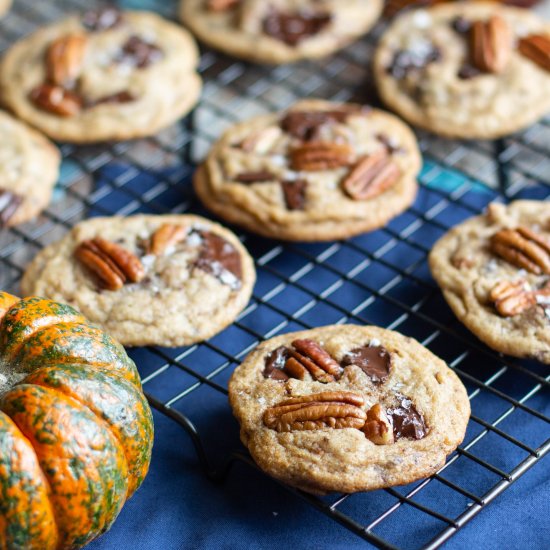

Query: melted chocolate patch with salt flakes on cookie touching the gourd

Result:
[196,230,242,290]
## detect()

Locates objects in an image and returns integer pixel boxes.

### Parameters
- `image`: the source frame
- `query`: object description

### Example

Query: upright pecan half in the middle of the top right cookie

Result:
[470,15,512,73]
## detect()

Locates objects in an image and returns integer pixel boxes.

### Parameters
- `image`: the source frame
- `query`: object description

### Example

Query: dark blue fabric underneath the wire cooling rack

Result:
[80,157,550,550]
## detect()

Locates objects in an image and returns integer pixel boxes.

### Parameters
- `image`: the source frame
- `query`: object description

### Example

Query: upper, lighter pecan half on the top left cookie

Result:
[46,34,88,88]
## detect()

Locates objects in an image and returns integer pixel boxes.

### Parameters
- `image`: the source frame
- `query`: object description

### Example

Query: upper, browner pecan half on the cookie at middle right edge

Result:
[490,226,550,275]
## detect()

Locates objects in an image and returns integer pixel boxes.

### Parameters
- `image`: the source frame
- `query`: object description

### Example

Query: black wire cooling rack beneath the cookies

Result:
[0,0,550,548]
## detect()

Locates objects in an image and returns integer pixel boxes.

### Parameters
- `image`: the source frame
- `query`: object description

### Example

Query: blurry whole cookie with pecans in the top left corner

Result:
[0,8,201,143]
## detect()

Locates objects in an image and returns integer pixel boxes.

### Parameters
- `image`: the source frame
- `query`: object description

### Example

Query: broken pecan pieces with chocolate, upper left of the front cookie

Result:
[264,338,343,383]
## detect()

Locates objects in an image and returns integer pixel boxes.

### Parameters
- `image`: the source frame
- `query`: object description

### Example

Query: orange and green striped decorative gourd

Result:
[0,292,153,550]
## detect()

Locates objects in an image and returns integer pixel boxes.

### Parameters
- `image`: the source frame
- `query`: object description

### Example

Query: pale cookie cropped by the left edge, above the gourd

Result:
[0,111,61,228]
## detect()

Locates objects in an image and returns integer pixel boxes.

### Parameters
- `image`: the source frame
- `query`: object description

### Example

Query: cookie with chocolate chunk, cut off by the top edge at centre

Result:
[180,0,383,64]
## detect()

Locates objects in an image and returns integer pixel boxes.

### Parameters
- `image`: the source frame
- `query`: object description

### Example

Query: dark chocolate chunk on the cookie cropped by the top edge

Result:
[262,10,332,46]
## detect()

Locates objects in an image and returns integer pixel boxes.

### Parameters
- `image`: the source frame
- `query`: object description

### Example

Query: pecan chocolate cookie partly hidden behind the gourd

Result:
[21,215,255,346]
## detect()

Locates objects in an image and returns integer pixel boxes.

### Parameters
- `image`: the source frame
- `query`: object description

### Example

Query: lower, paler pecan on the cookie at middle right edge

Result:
[489,279,550,317]
